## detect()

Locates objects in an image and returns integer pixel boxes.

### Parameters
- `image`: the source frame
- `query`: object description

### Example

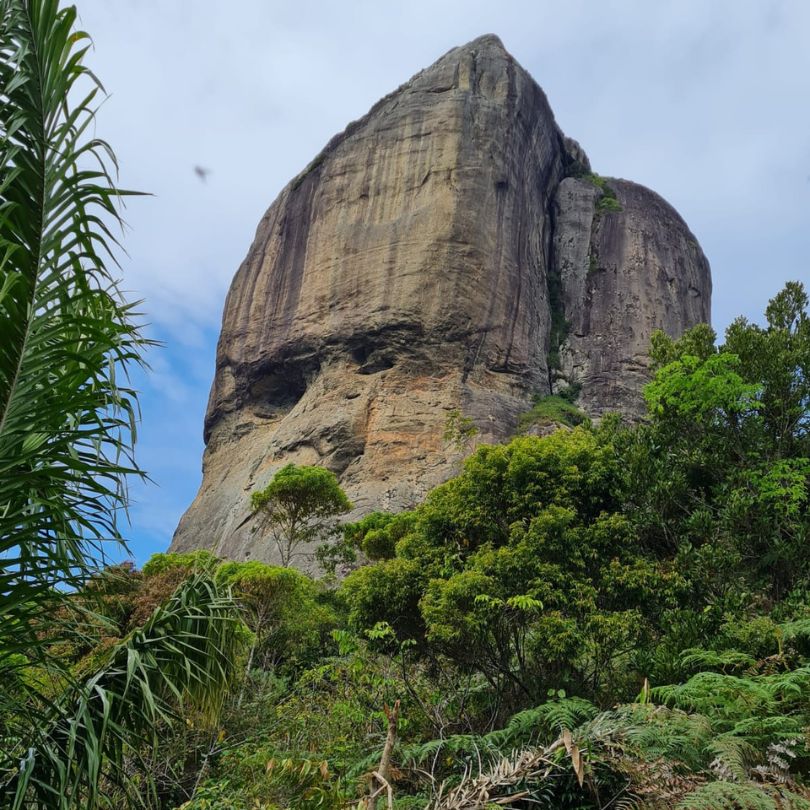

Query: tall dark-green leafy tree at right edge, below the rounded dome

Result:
[627,282,810,597]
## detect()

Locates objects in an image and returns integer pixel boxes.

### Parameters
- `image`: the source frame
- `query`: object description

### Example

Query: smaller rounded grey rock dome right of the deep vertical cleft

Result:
[552,178,711,416]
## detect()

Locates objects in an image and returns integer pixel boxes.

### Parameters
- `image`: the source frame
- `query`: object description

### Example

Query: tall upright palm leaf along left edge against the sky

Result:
[0,0,147,692]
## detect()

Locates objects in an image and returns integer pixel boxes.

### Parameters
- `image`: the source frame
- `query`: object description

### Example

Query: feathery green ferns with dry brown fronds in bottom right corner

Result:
[400,664,810,810]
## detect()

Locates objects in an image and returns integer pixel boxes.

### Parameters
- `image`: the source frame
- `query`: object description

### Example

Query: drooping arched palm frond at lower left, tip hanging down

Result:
[0,574,239,810]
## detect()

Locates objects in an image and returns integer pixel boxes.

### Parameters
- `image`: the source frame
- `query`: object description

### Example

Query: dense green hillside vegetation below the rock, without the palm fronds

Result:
[11,283,810,810]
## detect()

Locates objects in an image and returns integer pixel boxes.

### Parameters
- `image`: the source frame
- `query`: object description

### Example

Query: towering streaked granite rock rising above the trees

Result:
[172,36,711,559]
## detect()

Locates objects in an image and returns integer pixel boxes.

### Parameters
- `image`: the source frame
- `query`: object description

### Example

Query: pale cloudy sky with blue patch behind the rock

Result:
[72,0,810,563]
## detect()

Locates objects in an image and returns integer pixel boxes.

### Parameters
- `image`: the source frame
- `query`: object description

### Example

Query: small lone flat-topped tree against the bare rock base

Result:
[250,464,352,568]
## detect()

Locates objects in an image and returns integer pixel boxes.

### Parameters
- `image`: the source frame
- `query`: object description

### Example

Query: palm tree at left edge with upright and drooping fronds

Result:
[0,0,240,807]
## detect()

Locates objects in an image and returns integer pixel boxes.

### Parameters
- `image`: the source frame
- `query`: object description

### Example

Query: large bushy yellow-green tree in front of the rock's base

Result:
[342,428,677,709]
